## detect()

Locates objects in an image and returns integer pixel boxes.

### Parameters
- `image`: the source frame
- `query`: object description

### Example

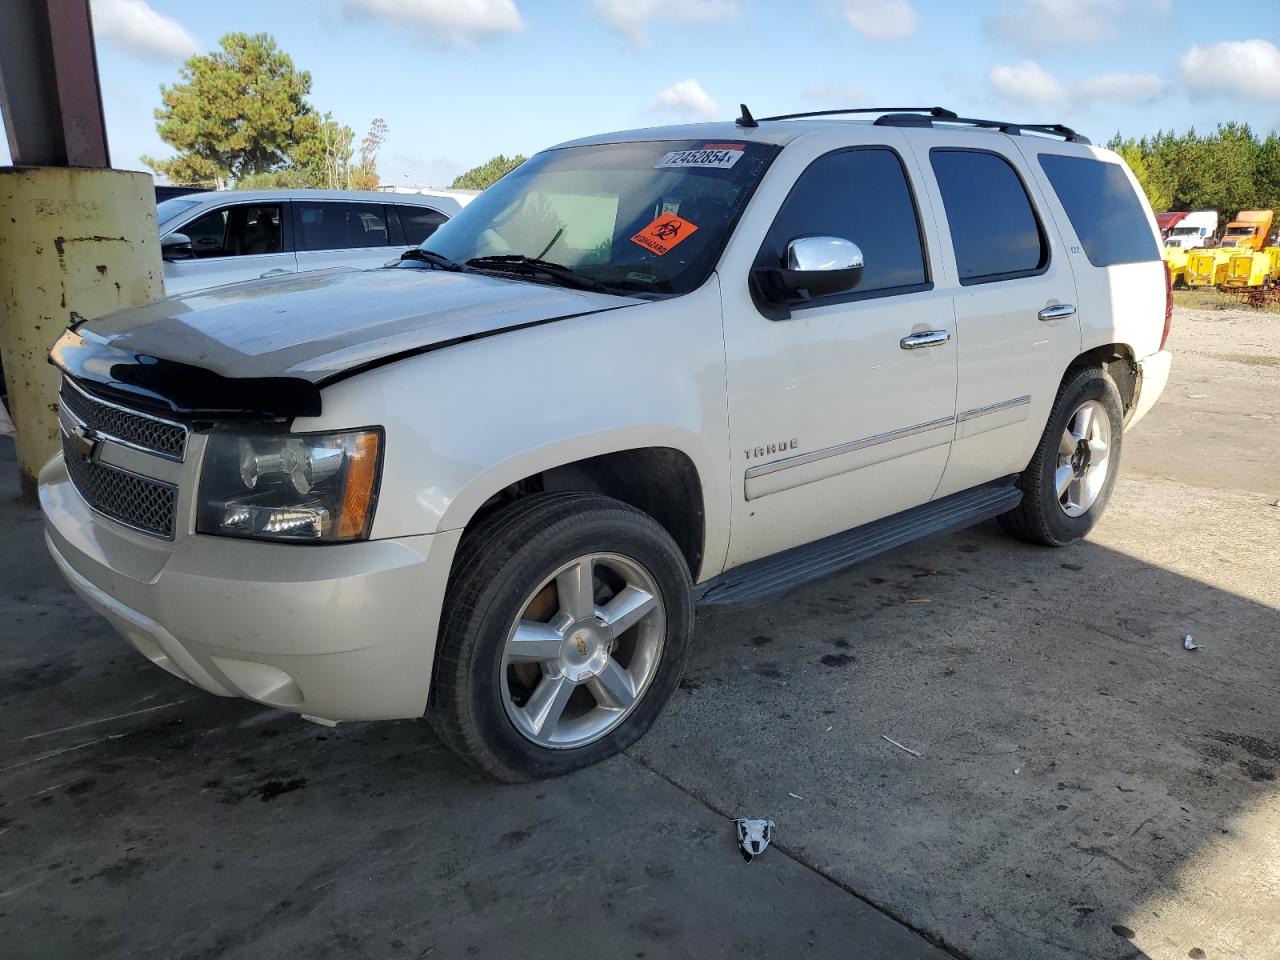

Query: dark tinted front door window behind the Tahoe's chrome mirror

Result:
[762,148,928,296]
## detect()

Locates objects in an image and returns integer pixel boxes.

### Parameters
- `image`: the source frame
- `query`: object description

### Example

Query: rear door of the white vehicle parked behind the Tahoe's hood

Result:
[293,200,402,271]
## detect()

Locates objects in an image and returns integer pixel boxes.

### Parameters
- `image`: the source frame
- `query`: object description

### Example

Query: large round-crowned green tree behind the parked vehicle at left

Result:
[142,33,314,186]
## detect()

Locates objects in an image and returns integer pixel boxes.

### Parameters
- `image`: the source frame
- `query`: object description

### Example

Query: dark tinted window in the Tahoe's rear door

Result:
[929,150,1048,283]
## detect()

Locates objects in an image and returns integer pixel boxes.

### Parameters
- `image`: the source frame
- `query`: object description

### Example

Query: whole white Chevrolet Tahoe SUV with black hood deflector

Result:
[40,109,1170,780]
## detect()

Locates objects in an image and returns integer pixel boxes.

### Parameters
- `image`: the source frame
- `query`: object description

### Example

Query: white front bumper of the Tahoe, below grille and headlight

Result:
[40,454,461,721]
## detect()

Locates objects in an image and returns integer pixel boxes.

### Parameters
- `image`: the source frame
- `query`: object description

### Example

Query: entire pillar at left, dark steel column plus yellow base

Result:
[0,0,164,500]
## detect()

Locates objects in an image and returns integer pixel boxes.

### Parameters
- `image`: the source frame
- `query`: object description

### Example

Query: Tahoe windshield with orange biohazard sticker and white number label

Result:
[419,141,778,297]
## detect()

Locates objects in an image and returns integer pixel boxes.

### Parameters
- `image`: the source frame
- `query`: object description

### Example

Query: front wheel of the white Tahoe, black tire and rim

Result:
[426,493,694,782]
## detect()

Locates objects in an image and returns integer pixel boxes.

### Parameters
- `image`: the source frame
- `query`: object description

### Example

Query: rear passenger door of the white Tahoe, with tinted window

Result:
[910,129,1080,497]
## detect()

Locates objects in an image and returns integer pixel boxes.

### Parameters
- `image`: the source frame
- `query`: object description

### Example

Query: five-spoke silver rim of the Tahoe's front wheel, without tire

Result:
[502,553,667,749]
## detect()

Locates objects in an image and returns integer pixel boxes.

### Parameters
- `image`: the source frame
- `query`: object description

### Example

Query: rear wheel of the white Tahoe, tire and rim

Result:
[998,366,1124,547]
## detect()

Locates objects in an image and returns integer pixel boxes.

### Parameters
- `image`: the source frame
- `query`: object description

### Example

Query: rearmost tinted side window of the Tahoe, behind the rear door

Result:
[1041,154,1176,266]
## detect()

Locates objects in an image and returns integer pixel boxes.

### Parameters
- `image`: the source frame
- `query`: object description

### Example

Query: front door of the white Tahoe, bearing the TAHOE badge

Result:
[722,135,956,567]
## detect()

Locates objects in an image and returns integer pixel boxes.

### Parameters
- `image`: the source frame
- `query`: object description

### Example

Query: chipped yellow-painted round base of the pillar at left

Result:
[0,166,164,502]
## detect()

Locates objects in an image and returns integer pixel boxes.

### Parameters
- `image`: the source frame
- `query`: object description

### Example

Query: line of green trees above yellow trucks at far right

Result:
[1107,122,1280,221]
